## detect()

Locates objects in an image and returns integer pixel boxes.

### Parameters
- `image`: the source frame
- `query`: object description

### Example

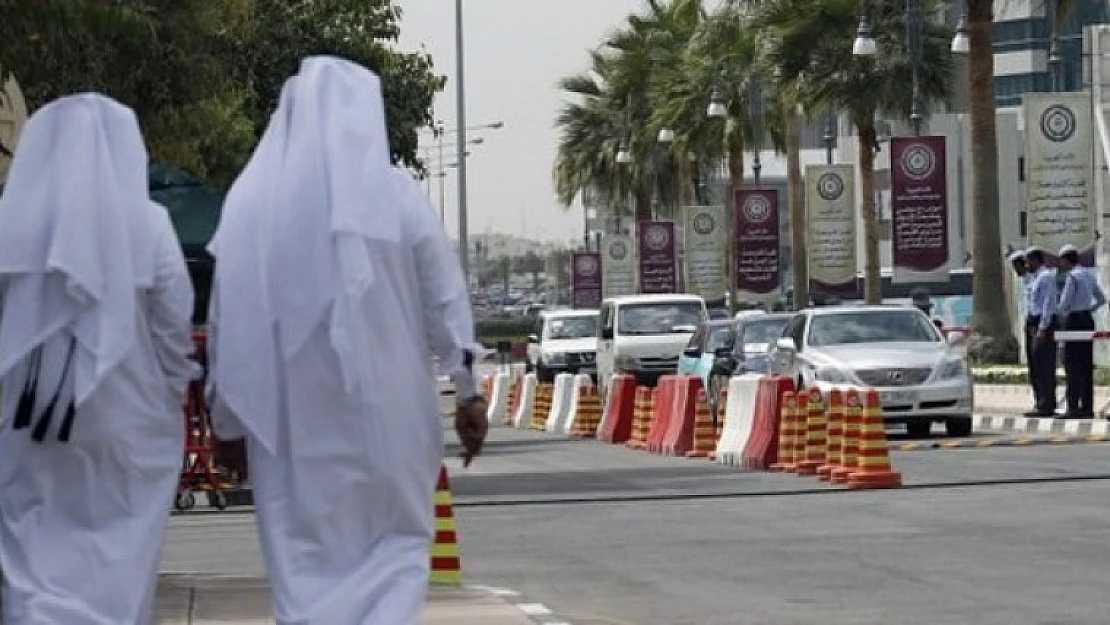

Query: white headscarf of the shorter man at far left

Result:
[0,93,157,405]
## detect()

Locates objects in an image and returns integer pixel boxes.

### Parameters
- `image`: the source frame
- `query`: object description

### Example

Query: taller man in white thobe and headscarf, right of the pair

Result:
[209,57,486,625]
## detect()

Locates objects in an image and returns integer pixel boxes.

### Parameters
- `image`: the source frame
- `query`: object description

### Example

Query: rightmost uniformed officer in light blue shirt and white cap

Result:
[1060,244,1107,419]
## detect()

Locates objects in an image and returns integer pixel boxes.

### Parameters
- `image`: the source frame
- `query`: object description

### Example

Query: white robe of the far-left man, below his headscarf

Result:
[0,204,193,625]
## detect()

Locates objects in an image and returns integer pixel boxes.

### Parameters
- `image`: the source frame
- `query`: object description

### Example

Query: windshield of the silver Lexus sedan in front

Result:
[809,310,940,347]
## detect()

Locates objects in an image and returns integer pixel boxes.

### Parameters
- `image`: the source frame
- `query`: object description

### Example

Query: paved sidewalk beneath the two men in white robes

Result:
[154,575,533,625]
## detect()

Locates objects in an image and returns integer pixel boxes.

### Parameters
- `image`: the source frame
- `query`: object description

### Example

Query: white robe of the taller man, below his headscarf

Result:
[209,172,476,625]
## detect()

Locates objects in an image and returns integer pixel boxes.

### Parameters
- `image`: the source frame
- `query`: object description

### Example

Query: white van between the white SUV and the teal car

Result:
[597,294,708,396]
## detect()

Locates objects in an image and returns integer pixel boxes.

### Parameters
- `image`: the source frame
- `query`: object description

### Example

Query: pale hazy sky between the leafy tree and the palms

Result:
[397,0,642,241]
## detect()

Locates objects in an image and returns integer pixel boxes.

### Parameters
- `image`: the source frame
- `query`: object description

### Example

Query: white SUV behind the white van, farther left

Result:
[527,310,598,382]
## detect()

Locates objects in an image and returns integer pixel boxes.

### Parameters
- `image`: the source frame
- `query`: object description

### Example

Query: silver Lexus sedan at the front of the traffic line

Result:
[771,305,973,436]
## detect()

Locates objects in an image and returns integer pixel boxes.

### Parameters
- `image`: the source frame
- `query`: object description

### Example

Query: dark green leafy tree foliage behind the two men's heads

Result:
[0,0,444,184]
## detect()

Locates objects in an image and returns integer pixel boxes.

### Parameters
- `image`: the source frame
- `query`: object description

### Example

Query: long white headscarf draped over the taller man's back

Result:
[209,57,401,450]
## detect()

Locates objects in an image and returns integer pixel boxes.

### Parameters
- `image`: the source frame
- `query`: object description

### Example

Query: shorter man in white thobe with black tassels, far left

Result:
[0,94,194,625]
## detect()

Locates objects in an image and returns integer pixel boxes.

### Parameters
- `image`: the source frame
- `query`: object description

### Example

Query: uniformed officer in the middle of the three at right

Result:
[1026,248,1057,416]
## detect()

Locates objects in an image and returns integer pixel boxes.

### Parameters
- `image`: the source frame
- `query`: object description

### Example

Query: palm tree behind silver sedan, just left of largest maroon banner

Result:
[760,0,951,303]
